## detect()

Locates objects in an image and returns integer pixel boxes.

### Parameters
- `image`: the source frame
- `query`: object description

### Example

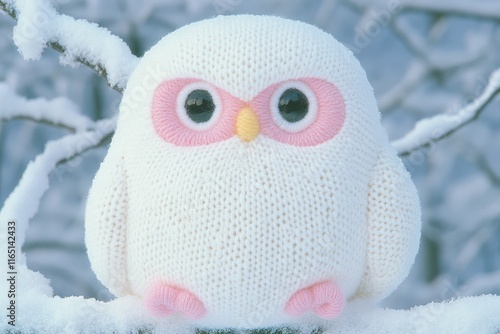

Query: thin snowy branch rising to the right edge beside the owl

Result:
[392,69,500,156]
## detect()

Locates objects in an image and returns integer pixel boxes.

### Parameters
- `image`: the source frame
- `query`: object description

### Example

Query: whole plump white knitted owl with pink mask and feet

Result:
[86,15,420,328]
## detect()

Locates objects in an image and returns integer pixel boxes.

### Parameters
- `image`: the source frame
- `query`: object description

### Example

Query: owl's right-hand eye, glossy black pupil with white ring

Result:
[270,81,318,133]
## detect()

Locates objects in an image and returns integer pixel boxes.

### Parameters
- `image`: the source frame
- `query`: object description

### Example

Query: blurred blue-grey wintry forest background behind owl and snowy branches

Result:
[0,0,500,308]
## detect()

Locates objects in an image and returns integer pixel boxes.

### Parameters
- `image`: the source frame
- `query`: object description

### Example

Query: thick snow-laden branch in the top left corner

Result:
[0,0,138,92]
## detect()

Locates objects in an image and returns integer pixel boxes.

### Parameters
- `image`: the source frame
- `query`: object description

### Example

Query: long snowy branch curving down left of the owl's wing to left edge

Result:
[0,118,115,264]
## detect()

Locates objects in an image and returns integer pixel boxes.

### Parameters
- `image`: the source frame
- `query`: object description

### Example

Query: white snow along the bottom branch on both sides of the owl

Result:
[0,266,500,334]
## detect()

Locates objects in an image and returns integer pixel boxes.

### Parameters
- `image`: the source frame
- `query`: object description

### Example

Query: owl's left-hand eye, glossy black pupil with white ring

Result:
[177,82,221,131]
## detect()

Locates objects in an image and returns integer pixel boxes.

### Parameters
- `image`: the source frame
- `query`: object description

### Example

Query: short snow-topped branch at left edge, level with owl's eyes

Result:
[0,83,94,132]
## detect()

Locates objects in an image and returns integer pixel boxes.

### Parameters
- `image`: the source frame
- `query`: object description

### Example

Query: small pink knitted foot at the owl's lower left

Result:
[144,283,207,320]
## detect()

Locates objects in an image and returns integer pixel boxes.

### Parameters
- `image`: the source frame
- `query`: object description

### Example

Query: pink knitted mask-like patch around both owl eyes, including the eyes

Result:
[152,78,345,146]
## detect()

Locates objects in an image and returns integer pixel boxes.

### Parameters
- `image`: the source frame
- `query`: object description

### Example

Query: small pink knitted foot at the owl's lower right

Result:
[285,282,345,319]
